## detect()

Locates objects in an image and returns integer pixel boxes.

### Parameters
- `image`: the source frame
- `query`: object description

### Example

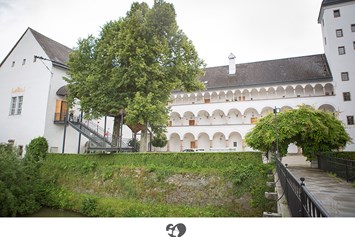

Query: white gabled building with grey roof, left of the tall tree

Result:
[0,28,84,155]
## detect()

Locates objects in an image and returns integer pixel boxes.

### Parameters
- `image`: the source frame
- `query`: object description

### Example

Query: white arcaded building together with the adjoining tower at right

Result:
[165,0,355,152]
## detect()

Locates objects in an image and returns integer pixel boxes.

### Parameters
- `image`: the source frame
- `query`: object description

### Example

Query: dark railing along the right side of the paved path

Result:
[318,153,355,182]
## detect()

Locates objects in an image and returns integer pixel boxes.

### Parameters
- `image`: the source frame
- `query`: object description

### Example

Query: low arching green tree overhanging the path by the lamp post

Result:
[245,105,351,160]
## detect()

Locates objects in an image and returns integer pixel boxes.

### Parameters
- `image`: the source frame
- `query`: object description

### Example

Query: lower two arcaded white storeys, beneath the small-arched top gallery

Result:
[165,92,336,153]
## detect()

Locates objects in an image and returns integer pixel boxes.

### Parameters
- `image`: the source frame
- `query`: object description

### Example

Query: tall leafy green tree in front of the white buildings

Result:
[67,0,204,151]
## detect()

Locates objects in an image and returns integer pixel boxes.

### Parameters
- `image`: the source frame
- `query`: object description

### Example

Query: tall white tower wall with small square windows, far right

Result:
[320,1,355,151]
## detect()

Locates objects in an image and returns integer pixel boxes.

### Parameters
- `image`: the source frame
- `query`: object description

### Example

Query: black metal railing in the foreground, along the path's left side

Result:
[276,159,329,217]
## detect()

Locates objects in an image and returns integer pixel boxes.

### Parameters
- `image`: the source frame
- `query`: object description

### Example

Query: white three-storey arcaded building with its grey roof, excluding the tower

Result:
[167,55,336,151]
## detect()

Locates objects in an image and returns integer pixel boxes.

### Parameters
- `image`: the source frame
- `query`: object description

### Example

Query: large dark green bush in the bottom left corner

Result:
[0,144,43,216]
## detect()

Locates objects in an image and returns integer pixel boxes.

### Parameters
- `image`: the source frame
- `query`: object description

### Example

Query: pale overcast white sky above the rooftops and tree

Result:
[0,0,324,67]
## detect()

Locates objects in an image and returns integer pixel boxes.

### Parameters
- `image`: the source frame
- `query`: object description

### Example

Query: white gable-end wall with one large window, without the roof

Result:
[0,31,51,154]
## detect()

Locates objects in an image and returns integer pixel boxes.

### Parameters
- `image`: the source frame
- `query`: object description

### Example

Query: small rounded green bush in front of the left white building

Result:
[25,137,48,162]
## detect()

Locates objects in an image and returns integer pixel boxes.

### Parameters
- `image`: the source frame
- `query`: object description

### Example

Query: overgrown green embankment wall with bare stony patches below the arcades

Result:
[40,153,274,217]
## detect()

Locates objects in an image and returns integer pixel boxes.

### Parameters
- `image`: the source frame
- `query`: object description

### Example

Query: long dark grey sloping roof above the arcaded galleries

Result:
[199,54,332,89]
